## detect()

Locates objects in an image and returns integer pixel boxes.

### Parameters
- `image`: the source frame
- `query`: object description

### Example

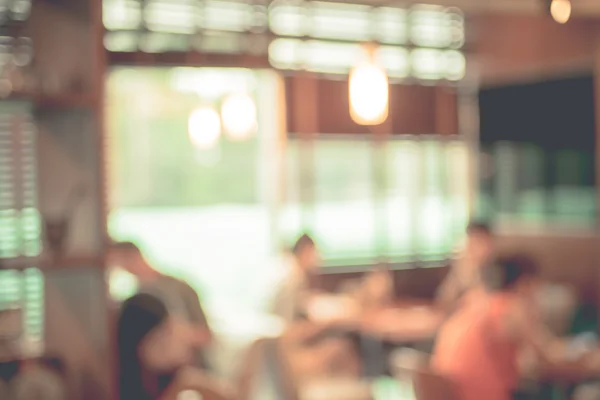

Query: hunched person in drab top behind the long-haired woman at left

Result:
[109,242,212,369]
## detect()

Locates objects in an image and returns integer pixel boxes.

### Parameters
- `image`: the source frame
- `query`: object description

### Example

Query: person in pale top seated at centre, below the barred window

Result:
[273,234,360,379]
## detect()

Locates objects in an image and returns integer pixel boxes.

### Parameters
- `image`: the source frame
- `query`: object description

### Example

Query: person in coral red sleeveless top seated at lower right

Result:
[432,255,580,400]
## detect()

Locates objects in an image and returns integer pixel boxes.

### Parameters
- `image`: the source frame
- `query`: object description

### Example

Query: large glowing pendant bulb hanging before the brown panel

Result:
[349,63,389,125]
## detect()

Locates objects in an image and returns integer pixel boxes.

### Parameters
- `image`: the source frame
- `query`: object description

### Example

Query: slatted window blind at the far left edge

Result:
[0,101,43,346]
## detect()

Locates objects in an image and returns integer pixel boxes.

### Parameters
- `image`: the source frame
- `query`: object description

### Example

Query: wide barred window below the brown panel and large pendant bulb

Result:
[280,135,469,266]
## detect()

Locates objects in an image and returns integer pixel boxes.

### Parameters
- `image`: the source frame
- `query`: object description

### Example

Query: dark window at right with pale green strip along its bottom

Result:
[479,74,597,228]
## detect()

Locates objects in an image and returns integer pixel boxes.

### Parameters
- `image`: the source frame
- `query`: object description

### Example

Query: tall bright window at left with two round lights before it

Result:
[107,68,278,326]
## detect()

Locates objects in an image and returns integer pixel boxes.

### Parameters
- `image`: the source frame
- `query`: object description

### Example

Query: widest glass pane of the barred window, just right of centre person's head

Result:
[314,140,376,262]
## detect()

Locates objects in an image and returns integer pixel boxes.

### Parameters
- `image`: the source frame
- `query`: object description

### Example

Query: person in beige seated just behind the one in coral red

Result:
[436,222,494,313]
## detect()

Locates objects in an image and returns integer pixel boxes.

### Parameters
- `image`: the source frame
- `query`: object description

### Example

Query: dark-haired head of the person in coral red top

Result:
[481,254,538,295]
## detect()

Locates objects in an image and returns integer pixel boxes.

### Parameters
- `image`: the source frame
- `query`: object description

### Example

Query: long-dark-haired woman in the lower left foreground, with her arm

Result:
[117,294,233,400]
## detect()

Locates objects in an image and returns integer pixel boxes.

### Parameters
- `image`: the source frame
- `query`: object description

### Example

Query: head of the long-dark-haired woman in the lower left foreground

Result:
[117,294,190,393]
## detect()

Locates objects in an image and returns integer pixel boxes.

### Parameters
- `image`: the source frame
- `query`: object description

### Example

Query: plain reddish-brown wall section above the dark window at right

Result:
[468,14,600,84]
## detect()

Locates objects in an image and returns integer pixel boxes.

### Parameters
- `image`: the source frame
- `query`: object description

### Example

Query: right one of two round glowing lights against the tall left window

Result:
[221,94,257,140]
